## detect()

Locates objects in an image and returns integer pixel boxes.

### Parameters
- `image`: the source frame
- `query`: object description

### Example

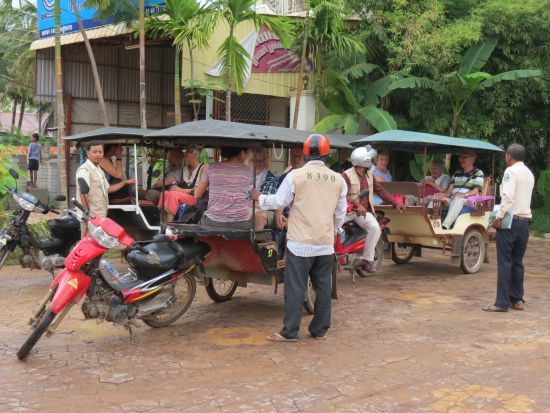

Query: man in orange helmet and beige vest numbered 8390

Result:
[252,134,347,342]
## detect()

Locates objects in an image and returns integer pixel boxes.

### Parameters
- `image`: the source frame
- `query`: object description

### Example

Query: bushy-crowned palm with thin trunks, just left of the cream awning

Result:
[145,0,214,124]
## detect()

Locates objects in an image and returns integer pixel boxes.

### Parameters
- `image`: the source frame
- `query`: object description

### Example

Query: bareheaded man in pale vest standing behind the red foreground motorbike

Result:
[76,141,136,236]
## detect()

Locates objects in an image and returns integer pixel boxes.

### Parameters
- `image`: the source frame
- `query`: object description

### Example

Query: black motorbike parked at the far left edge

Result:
[0,169,80,275]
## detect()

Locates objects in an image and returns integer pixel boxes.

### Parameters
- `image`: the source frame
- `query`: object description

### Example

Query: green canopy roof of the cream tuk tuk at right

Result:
[351,130,503,153]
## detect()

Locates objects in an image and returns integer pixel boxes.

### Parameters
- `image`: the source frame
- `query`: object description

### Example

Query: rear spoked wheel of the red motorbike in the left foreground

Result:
[143,275,197,328]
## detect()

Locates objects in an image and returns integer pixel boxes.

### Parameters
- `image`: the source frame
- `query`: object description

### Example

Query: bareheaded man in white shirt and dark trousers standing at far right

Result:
[483,144,535,312]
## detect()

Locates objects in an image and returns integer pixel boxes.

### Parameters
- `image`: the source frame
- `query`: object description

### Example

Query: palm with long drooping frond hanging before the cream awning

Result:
[211,0,294,121]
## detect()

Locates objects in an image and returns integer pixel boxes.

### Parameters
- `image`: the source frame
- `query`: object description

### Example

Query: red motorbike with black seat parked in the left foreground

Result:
[17,180,210,360]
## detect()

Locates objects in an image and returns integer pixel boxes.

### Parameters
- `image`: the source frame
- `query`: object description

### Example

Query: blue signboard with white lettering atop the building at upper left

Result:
[36,0,165,39]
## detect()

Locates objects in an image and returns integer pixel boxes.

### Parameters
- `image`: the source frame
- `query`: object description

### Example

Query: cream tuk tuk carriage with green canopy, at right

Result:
[352,130,502,274]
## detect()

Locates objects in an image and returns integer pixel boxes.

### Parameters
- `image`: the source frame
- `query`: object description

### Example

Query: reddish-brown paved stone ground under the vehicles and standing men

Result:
[0,239,550,413]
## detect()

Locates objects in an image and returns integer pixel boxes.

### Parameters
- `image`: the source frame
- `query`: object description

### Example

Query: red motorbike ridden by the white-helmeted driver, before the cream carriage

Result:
[335,212,390,281]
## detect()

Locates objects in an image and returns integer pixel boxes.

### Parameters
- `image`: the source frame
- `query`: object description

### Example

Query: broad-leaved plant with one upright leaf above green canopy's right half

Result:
[390,37,541,136]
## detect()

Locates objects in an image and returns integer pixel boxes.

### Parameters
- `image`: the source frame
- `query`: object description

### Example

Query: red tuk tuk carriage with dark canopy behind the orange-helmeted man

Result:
[145,120,351,313]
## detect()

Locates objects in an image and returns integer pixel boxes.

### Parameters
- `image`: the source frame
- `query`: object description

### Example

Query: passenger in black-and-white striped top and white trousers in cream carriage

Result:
[434,149,483,229]
